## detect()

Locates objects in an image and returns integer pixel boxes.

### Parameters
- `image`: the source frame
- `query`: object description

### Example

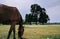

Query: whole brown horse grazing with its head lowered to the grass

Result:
[0,4,24,39]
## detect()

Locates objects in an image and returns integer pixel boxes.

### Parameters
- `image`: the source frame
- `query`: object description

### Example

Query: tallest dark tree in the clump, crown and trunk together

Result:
[31,4,42,24]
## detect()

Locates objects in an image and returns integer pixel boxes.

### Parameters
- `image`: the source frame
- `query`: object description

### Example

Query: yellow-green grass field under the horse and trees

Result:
[0,25,60,39]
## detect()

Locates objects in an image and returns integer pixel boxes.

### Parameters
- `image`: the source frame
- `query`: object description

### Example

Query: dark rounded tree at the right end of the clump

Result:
[39,8,49,24]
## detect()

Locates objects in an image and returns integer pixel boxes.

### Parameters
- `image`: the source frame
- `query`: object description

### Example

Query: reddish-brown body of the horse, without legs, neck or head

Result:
[0,4,20,22]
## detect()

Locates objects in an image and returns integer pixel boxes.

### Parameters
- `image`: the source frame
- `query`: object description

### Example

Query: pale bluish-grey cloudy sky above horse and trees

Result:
[0,0,60,23]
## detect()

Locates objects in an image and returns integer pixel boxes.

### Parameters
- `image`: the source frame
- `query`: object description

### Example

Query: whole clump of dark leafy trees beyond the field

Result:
[25,4,50,24]
